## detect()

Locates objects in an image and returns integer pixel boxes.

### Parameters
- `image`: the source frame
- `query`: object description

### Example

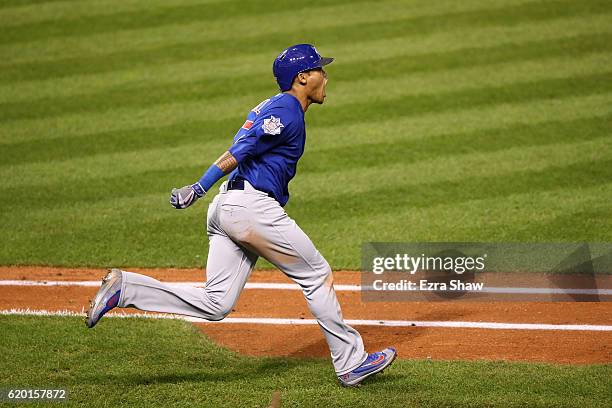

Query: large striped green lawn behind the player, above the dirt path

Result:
[0,0,612,268]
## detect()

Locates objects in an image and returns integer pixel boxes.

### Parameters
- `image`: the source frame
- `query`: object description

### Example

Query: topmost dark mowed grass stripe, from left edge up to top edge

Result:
[0,0,365,44]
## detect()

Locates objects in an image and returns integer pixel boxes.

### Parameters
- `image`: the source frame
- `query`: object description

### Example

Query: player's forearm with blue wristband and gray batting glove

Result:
[170,151,238,209]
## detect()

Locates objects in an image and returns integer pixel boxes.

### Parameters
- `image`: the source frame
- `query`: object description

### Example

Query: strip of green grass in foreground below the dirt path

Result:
[0,316,612,408]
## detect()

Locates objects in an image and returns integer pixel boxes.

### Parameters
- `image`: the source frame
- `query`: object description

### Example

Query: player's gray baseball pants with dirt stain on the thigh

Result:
[119,182,367,375]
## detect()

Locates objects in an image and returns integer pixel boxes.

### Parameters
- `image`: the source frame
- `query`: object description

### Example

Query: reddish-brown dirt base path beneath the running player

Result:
[0,267,612,364]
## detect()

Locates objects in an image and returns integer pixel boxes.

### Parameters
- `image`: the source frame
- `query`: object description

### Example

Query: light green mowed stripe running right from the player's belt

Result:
[298,137,612,199]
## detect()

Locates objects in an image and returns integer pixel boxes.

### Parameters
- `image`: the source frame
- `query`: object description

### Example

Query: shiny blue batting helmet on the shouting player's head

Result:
[272,44,334,91]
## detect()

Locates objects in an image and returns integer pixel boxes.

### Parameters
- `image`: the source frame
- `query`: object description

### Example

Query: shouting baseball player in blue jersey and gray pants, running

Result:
[87,44,396,386]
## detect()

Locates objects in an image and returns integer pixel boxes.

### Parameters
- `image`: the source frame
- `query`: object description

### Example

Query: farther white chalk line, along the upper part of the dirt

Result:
[0,280,612,296]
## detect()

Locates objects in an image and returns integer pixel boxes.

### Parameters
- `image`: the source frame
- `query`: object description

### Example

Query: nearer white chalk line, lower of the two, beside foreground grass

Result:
[0,309,612,332]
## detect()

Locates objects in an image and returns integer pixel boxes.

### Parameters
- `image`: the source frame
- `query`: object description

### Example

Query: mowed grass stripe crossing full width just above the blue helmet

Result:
[0,2,612,77]
